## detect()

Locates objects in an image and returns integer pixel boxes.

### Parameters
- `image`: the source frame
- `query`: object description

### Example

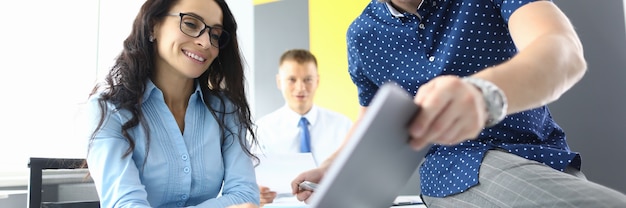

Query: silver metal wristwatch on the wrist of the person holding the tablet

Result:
[462,77,508,127]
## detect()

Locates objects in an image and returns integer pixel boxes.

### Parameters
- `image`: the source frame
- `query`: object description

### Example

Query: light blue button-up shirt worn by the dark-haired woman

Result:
[85,81,259,207]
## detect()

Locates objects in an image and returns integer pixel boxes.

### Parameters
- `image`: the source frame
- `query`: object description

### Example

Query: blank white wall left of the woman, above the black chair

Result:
[0,0,98,185]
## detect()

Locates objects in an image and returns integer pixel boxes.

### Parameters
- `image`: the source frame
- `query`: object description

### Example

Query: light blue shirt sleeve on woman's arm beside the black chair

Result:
[86,98,150,208]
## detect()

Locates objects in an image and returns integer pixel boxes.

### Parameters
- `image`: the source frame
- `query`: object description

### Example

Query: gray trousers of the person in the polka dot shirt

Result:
[422,150,626,208]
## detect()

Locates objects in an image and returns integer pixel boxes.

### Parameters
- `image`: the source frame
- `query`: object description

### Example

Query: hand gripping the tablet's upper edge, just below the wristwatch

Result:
[409,76,487,150]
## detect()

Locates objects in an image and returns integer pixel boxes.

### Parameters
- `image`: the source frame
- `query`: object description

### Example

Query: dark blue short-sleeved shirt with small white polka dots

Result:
[347,0,580,197]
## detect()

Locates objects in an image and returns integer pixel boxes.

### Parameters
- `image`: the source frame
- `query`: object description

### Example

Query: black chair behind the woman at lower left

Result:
[27,157,100,208]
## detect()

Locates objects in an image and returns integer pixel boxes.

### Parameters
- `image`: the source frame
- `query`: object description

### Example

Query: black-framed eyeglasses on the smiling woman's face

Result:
[168,13,230,48]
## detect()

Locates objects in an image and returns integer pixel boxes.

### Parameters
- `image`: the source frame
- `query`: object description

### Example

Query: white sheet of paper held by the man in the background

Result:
[255,153,317,198]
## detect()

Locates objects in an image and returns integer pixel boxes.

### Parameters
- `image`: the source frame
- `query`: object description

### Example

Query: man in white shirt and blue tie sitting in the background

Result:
[256,49,352,205]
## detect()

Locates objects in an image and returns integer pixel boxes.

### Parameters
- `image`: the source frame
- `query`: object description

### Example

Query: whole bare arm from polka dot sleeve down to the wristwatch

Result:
[474,2,587,114]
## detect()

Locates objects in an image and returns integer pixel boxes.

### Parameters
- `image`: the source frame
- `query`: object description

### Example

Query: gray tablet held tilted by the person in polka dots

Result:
[309,83,430,208]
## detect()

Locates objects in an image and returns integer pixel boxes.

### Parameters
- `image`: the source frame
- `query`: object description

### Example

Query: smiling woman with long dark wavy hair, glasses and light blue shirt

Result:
[84,0,259,207]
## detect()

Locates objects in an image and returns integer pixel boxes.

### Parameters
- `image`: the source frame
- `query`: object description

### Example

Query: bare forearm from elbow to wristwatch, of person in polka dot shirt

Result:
[475,35,586,114]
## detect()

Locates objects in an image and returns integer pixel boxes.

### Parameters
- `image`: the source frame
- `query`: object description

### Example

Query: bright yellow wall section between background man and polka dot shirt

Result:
[309,0,369,120]
